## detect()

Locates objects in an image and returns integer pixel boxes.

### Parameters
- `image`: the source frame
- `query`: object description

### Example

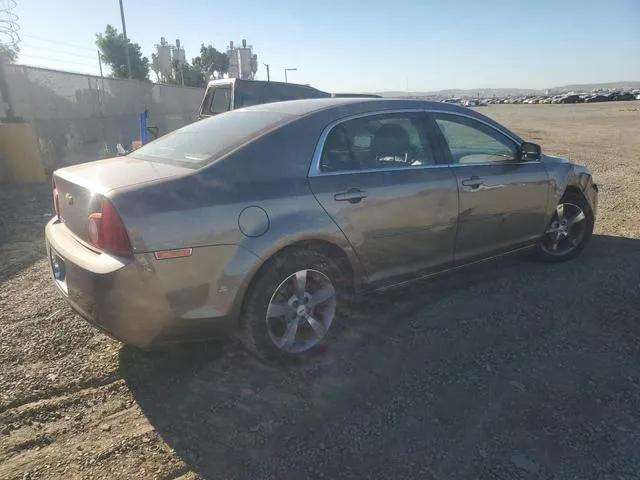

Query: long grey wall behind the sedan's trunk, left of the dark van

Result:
[0,65,204,172]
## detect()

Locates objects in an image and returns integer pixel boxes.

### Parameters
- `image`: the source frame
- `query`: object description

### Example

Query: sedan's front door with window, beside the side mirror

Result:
[433,113,549,263]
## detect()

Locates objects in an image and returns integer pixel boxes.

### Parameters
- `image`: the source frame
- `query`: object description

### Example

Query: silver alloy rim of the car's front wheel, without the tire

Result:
[541,203,587,256]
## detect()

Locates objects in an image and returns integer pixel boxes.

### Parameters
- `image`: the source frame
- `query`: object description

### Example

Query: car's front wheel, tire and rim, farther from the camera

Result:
[537,192,594,262]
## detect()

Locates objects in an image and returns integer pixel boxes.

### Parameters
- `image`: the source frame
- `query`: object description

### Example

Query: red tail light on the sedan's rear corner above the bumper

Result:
[87,198,133,257]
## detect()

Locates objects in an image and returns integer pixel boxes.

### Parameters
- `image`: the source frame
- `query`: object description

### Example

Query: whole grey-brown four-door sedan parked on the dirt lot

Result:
[45,98,598,358]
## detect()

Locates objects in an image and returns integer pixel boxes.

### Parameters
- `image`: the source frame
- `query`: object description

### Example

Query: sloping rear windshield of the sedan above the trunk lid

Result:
[130,111,291,168]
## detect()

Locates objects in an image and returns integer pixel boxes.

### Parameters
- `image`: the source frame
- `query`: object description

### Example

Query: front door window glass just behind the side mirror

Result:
[434,114,518,164]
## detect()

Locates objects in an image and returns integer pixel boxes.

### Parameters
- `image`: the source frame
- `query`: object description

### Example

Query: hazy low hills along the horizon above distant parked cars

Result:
[378,81,640,98]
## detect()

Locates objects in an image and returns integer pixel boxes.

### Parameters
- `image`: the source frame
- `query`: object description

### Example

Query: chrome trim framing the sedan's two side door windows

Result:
[308,108,540,177]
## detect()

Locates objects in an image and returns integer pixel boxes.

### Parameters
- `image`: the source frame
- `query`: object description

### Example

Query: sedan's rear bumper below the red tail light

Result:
[45,219,257,348]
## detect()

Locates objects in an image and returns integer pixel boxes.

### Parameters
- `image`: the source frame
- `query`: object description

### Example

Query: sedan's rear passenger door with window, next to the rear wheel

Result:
[309,111,458,283]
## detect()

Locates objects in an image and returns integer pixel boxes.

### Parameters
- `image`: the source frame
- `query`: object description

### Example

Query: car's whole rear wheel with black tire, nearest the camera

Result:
[239,249,345,362]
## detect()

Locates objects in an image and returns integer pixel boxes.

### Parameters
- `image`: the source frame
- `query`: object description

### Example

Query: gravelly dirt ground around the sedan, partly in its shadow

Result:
[0,102,640,480]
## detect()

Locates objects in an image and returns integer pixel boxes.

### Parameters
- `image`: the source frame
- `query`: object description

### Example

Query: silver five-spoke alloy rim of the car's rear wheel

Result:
[266,269,337,353]
